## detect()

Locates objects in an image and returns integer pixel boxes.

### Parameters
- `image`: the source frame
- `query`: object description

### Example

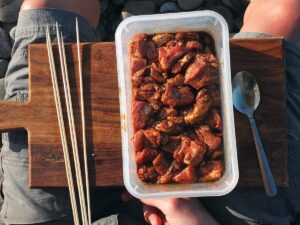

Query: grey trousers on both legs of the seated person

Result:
[0,9,300,225]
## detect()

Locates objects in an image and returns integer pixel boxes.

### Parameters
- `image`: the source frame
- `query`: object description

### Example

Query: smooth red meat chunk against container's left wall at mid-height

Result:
[132,101,152,131]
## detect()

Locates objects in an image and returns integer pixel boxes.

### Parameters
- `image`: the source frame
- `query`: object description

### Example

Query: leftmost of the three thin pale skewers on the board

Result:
[46,26,79,225]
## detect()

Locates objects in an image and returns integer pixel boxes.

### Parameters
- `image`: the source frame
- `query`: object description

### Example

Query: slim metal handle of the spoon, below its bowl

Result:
[249,117,277,197]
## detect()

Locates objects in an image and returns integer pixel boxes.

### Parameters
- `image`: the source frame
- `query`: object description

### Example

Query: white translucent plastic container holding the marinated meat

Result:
[115,11,239,198]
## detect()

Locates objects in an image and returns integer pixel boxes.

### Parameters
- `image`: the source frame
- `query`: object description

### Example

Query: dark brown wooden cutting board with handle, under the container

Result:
[0,38,287,187]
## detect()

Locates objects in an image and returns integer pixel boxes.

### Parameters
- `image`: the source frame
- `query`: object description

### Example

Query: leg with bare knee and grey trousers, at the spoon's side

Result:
[201,0,300,225]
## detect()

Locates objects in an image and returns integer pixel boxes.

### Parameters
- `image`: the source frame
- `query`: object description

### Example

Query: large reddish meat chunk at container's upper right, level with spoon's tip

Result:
[184,53,218,90]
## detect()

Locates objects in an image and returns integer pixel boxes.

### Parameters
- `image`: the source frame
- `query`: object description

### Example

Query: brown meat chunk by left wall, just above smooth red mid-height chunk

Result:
[133,83,161,103]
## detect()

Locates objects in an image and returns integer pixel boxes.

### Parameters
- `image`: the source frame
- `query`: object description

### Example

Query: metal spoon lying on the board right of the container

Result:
[232,71,277,197]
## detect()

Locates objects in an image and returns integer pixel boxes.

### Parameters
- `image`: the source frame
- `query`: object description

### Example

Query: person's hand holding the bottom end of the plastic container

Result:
[141,198,218,225]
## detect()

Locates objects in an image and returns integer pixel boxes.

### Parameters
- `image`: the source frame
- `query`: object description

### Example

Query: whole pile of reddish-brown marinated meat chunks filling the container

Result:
[128,32,224,184]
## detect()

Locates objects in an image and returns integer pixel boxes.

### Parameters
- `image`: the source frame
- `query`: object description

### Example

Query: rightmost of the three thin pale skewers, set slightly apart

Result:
[76,17,92,225]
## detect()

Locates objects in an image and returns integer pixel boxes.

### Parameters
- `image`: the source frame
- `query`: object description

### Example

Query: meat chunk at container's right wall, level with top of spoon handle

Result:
[195,125,222,151]
